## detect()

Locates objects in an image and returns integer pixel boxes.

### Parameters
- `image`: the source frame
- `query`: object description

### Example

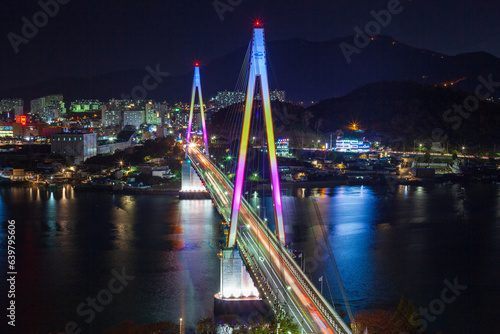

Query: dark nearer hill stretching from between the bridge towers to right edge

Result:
[209,81,500,152]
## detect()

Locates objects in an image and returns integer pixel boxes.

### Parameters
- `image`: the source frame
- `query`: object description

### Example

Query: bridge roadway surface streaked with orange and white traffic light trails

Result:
[189,147,351,334]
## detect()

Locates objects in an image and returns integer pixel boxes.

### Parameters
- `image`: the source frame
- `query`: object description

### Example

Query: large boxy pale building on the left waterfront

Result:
[50,132,97,164]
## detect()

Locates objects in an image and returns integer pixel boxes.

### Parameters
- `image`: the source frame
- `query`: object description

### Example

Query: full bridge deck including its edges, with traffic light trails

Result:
[190,148,352,334]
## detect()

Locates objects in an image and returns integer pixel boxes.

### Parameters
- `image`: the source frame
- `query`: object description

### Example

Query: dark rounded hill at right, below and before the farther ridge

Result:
[307,81,500,149]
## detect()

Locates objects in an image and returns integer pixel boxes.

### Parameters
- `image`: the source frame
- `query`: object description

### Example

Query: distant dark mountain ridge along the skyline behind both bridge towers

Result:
[0,36,500,104]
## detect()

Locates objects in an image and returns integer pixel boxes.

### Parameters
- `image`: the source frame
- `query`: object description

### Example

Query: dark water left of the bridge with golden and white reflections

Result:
[0,187,220,332]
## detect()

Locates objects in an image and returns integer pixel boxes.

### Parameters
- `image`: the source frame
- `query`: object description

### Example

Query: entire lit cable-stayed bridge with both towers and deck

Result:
[185,23,356,334]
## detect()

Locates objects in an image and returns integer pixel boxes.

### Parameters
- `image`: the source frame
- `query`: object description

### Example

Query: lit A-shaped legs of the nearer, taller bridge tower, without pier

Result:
[227,22,286,248]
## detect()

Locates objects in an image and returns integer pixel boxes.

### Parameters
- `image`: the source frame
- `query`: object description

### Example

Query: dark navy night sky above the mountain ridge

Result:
[0,0,500,89]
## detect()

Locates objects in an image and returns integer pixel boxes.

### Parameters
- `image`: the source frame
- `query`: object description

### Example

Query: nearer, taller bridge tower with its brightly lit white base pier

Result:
[215,22,285,314]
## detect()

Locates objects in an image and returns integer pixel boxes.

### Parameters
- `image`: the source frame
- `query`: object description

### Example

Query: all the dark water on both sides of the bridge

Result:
[0,184,500,334]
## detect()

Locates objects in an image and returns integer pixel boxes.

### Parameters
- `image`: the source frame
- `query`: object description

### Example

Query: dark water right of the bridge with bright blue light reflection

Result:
[254,184,500,333]
